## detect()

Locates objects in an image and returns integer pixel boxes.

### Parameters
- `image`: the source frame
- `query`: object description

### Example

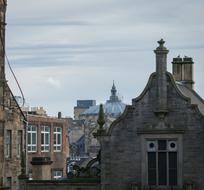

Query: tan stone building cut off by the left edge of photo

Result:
[0,0,26,190]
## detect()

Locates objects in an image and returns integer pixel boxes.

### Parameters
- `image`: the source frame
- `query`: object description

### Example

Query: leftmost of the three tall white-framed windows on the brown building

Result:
[28,125,37,152]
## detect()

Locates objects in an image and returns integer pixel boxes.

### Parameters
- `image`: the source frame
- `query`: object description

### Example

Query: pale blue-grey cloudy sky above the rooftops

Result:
[6,0,204,116]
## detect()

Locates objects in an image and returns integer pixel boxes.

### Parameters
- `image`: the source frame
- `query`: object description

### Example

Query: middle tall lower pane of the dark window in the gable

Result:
[158,152,167,185]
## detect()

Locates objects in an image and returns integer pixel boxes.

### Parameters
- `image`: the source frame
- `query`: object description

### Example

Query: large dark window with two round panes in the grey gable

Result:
[147,140,178,186]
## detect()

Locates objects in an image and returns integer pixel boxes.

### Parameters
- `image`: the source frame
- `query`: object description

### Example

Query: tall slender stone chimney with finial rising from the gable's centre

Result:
[154,39,169,113]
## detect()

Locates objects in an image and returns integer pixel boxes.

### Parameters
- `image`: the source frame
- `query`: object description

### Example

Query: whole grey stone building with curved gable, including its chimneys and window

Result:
[96,40,204,190]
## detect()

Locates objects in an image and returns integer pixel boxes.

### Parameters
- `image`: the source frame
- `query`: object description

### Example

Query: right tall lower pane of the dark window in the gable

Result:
[169,152,177,185]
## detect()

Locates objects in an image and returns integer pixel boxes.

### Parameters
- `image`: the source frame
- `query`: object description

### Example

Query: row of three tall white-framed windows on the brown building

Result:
[28,125,62,152]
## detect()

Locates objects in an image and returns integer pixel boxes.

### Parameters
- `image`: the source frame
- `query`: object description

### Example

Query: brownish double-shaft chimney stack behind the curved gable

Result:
[172,56,194,89]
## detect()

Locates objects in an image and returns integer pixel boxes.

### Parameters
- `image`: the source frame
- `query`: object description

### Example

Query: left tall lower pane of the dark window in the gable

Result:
[148,152,156,185]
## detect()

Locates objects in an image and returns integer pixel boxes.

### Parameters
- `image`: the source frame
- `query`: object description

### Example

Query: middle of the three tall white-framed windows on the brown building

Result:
[41,126,50,152]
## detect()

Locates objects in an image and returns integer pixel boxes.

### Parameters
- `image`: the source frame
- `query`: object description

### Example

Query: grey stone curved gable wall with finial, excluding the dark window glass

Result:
[98,40,204,190]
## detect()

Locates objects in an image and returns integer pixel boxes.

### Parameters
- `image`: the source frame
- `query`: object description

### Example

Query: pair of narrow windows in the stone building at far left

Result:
[5,130,23,158]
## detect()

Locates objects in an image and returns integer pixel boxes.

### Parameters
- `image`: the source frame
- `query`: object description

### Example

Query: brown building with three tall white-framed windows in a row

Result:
[27,110,69,180]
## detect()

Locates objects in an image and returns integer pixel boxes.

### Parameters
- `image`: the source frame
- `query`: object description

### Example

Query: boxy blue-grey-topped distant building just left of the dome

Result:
[74,100,96,120]
